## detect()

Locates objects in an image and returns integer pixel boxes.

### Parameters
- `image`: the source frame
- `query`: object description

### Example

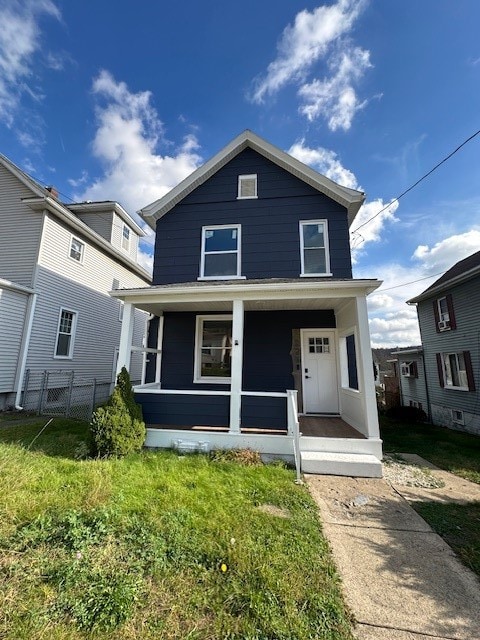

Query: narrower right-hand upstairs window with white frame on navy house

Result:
[300,220,332,276]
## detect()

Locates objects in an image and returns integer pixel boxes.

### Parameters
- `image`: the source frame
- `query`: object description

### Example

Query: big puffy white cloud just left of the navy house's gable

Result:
[78,71,205,271]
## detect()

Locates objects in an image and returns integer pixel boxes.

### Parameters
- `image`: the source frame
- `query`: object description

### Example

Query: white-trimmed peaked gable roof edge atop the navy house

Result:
[138,129,365,230]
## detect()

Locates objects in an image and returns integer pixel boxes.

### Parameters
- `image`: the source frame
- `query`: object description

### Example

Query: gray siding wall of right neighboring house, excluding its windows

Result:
[418,277,480,428]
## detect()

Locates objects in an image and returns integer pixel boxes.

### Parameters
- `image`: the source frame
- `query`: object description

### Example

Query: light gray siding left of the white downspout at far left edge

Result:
[0,285,28,393]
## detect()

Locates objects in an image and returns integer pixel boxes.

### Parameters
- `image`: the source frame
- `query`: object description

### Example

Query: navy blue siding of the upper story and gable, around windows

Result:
[153,149,352,284]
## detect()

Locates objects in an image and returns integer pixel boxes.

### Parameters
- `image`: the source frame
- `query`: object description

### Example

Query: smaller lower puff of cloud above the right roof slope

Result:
[298,47,372,131]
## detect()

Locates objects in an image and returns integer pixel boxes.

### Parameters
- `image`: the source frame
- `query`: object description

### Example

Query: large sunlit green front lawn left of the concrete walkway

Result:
[0,419,352,640]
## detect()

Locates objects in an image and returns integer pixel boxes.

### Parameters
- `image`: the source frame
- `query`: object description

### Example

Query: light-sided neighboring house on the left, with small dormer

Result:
[0,155,151,410]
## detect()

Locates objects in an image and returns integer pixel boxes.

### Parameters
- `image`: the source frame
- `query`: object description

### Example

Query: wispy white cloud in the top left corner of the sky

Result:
[0,0,60,127]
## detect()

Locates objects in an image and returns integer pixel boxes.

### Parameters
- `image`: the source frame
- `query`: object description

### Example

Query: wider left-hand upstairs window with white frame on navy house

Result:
[200,224,241,280]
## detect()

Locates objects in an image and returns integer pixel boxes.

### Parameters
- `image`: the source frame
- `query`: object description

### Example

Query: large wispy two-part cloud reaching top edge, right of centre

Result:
[250,0,372,131]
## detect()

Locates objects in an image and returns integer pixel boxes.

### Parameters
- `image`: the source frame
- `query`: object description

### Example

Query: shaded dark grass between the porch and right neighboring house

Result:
[381,416,480,484]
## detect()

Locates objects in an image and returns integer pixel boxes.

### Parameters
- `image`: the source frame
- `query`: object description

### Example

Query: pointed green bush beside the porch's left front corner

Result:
[90,367,146,457]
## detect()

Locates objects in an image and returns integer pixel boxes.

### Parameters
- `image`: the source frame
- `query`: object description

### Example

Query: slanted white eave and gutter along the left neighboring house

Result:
[22,196,152,282]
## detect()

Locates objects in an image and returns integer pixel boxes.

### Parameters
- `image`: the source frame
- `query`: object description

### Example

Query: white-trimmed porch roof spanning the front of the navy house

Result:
[110,278,382,315]
